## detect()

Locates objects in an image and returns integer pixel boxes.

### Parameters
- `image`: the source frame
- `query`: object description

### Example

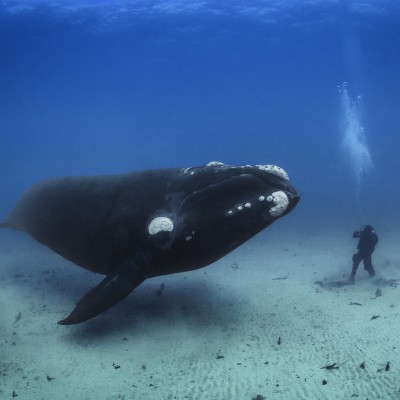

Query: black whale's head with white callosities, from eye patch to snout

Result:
[149,162,300,270]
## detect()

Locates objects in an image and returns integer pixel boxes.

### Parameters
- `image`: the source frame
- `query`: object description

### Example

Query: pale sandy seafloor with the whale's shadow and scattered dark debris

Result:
[0,222,400,400]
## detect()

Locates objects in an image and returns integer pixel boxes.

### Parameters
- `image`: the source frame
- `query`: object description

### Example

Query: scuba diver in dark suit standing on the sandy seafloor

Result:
[350,225,378,283]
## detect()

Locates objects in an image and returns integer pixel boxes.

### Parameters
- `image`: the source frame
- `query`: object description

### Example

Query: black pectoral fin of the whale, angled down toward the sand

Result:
[58,262,147,325]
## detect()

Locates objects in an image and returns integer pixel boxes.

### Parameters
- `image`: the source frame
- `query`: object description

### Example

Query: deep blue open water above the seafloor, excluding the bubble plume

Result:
[0,0,400,230]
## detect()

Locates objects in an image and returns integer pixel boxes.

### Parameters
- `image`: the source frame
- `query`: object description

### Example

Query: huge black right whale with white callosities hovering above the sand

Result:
[0,162,300,325]
